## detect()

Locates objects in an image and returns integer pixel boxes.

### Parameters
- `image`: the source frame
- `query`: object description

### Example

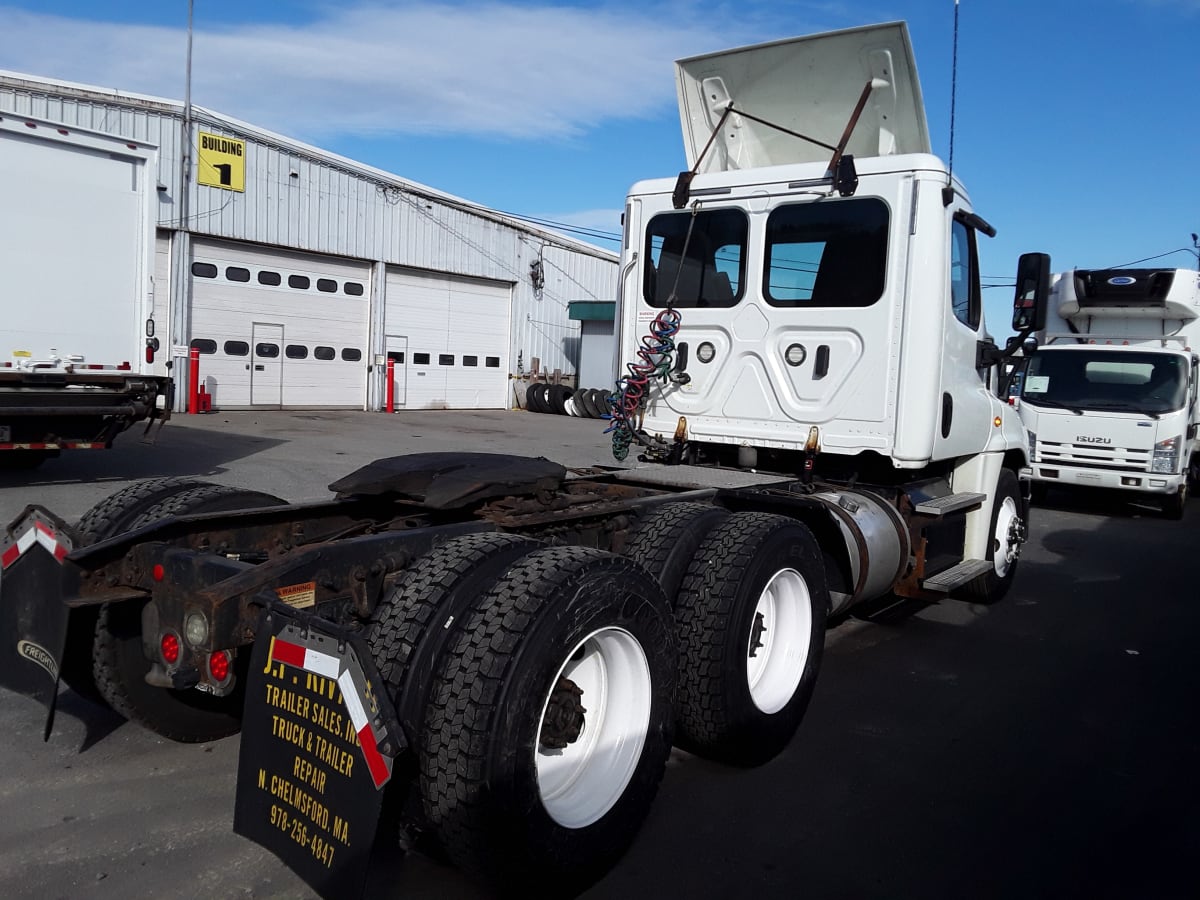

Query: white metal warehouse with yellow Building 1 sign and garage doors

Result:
[0,73,617,409]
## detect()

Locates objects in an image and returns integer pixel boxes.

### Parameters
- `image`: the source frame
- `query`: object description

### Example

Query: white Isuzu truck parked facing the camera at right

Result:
[1020,269,1200,518]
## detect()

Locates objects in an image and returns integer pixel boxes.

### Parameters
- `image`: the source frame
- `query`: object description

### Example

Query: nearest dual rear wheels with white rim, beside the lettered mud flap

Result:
[370,534,678,894]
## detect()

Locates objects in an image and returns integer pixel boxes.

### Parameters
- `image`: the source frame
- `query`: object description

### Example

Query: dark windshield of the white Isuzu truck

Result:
[1021,348,1188,415]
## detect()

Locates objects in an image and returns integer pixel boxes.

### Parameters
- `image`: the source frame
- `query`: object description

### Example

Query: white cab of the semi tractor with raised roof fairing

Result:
[616,23,1027,559]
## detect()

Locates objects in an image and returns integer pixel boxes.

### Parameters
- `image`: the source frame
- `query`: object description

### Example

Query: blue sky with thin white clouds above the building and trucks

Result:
[0,0,1200,334]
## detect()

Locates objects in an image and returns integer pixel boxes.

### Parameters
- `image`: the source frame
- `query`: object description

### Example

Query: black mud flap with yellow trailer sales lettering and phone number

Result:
[233,604,406,899]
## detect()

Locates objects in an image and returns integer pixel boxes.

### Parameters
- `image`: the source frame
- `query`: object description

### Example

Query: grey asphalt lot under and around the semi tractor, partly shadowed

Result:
[0,410,1200,900]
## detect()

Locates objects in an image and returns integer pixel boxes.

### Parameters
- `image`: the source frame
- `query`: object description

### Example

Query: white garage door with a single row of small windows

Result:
[384,269,512,409]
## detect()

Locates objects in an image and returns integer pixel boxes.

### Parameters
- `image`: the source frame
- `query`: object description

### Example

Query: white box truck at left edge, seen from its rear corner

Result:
[0,113,172,468]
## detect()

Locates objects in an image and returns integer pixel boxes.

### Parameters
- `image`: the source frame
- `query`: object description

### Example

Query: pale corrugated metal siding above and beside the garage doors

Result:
[0,74,617,374]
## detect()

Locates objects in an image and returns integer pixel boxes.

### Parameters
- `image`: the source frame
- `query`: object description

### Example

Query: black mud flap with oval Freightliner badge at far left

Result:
[0,506,79,739]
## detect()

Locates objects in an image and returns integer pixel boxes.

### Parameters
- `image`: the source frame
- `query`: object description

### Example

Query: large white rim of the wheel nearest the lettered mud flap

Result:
[534,628,653,828]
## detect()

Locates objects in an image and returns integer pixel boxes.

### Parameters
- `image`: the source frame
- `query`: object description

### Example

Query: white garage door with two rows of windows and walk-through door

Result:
[191,240,371,409]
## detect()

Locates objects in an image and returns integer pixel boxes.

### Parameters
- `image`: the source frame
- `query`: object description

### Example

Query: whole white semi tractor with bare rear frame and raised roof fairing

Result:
[0,23,1049,896]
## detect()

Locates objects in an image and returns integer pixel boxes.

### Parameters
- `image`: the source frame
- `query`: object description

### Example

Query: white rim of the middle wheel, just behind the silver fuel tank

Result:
[746,569,812,715]
